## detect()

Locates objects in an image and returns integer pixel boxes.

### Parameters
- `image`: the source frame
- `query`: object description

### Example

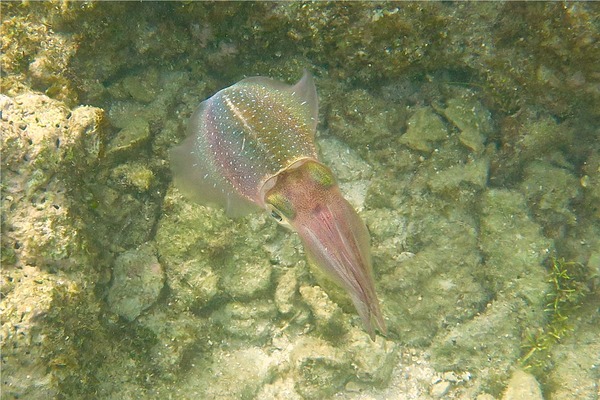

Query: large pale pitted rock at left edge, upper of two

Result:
[0,93,104,268]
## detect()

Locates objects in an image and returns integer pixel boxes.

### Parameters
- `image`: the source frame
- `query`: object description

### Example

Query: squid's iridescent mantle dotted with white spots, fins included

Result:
[174,75,317,212]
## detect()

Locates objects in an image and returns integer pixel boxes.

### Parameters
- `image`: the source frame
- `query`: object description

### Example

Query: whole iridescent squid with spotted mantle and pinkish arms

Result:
[170,72,386,340]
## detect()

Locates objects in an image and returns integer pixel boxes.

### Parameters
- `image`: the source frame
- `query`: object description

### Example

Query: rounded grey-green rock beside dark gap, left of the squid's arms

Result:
[107,244,164,321]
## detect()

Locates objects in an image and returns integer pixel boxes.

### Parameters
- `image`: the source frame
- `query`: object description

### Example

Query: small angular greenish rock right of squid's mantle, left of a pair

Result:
[400,107,448,153]
